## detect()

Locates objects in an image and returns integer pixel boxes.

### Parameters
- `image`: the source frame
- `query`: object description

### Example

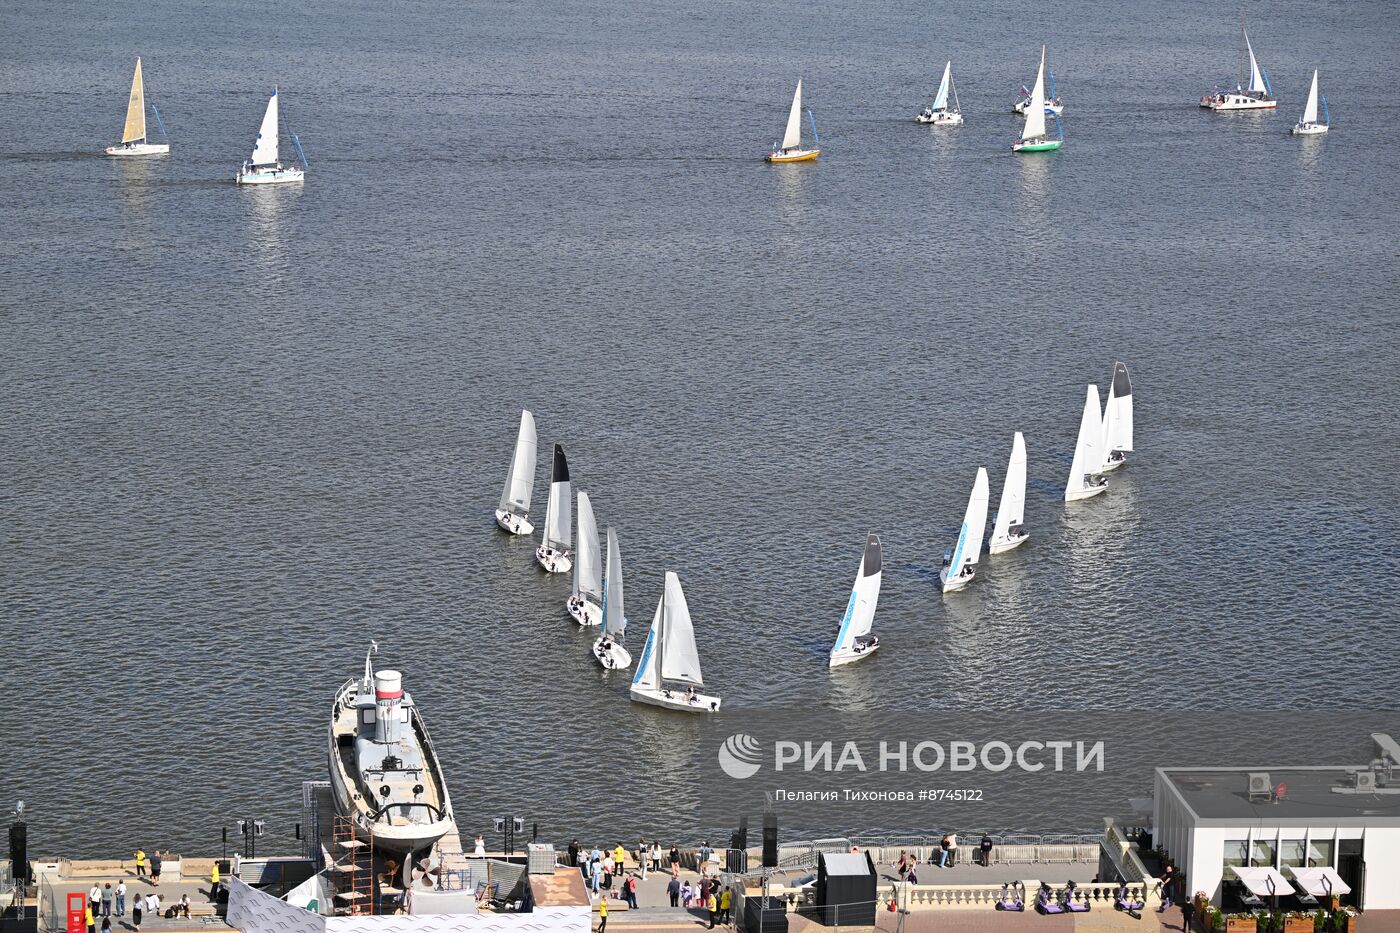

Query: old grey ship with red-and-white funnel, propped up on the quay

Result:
[329,643,456,853]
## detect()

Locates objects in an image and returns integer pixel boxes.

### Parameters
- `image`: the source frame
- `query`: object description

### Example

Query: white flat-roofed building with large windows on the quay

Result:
[1152,734,1400,909]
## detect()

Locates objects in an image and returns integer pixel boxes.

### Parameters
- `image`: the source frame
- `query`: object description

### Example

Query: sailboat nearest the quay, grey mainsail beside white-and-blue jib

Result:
[631,570,720,713]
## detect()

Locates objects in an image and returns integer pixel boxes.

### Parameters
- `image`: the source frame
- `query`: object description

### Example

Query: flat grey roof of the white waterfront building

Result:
[1158,768,1400,827]
